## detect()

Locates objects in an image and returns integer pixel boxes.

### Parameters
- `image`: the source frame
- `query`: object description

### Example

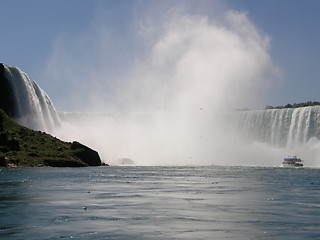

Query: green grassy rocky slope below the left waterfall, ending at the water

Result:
[0,109,101,167]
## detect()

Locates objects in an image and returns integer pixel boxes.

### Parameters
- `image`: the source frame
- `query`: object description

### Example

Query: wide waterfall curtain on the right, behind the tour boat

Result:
[233,106,320,147]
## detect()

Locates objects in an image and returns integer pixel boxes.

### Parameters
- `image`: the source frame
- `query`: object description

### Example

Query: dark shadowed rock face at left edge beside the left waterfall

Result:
[0,63,16,117]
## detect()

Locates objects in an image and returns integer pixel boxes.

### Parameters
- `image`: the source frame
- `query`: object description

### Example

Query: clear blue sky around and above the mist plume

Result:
[0,0,320,110]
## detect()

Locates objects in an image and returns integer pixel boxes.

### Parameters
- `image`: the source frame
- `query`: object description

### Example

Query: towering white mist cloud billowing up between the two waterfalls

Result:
[47,2,278,165]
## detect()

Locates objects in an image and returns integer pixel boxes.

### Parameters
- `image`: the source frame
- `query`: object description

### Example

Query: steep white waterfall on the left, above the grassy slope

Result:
[3,65,60,131]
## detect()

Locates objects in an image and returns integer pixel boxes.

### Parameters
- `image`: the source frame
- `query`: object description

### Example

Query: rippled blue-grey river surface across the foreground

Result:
[0,166,320,239]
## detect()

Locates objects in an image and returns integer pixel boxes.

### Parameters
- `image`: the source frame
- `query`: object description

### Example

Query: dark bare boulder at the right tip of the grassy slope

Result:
[71,141,101,166]
